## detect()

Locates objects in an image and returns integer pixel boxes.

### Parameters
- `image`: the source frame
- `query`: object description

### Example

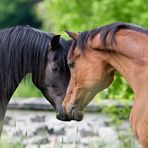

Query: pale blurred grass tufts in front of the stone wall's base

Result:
[0,115,139,148]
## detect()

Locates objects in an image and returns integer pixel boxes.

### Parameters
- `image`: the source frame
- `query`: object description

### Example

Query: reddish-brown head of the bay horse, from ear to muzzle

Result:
[57,32,114,121]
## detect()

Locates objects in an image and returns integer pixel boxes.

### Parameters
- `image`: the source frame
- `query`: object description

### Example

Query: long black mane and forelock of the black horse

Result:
[0,26,69,99]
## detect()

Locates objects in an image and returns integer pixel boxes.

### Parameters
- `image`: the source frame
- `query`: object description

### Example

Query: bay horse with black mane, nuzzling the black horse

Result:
[60,22,148,148]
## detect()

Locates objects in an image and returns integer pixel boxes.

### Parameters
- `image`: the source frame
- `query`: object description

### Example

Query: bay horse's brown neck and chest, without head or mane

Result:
[109,31,148,148]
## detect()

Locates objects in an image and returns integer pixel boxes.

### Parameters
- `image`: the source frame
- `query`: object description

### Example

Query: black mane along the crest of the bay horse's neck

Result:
[78,22,148,49]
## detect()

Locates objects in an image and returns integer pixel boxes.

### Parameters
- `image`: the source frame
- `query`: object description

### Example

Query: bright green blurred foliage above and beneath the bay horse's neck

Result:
[36,0,148,100]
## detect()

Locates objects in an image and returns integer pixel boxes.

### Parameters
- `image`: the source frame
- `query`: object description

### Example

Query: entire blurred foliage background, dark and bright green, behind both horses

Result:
[0,0,148,100]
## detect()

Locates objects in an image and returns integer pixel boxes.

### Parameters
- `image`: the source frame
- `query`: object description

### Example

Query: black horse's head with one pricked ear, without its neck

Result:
[32,35,70,112]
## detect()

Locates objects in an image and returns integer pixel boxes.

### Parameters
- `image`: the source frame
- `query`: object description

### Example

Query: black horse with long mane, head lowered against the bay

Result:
[0,26,70,133]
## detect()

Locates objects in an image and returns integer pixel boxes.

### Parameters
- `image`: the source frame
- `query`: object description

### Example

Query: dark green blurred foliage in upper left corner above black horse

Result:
[0,0,41,28]
